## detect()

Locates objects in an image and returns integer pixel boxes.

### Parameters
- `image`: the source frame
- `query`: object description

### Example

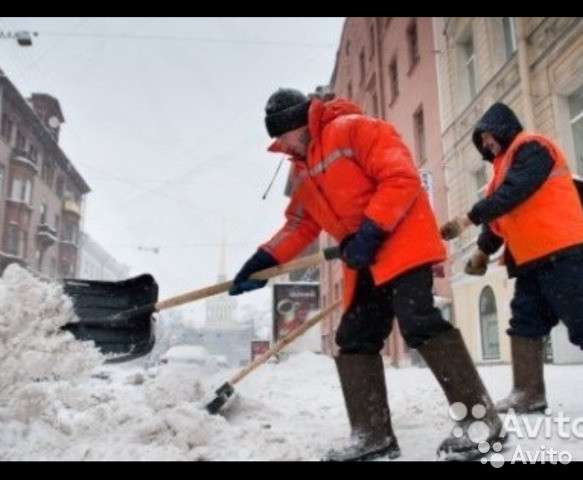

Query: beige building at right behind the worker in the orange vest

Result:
[434,17,583,363]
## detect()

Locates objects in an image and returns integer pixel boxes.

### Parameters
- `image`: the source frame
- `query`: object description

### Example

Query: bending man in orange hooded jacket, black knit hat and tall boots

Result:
[230,89,501,460]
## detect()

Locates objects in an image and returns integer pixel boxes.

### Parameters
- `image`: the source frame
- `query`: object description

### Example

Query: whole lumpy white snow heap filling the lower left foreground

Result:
[0,265,320,460]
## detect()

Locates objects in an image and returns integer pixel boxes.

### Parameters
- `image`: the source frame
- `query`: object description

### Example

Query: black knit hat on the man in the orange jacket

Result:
[265,88,310,137]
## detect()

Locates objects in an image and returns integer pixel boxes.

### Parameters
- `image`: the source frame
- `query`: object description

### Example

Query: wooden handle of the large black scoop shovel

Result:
[154,247,340,312]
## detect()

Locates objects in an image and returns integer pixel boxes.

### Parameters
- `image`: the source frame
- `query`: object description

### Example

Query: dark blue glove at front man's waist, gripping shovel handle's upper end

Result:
[340,218,387,270]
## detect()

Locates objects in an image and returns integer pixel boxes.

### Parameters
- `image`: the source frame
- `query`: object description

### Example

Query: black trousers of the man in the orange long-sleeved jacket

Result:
[336,265,453,354]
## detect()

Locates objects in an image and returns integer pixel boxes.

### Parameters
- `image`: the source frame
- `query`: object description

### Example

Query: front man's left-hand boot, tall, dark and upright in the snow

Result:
[324,354,401,462]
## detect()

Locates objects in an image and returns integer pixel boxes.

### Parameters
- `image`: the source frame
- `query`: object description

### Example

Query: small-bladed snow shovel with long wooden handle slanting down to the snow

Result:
[206,301,342,415]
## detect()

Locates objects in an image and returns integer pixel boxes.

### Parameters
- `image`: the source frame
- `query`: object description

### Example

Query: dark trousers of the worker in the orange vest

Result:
[507,254,583,348]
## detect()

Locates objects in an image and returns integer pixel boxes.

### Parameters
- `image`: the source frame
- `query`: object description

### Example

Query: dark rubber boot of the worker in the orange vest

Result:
[496,336,547,413]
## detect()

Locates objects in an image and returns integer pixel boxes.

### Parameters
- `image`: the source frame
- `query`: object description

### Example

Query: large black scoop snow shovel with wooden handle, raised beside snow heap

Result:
[63,247,340,362]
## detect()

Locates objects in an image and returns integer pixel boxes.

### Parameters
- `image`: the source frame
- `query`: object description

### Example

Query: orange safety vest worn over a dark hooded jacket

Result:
[487,132,583,265]
